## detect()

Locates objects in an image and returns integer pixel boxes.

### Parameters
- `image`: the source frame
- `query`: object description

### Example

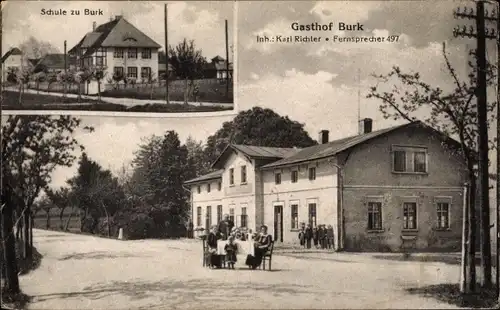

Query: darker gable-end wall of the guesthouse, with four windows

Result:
[343,130,466,251]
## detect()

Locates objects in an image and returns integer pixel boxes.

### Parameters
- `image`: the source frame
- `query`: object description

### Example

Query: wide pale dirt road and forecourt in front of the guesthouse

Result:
[21,230,464,309]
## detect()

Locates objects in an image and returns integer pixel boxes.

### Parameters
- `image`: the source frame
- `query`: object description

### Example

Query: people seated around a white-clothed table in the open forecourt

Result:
[207,214,272,269]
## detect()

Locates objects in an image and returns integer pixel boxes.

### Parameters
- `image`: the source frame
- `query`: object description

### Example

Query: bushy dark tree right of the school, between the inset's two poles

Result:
[167,39,206,104]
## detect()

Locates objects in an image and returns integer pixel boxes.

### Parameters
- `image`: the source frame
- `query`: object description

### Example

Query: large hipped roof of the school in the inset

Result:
[69,16,160,56]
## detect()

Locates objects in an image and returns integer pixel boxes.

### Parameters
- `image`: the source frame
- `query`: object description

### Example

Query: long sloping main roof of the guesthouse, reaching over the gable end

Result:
[262,121,460,169]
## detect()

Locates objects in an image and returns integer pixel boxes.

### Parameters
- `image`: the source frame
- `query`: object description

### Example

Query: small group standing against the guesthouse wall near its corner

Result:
[299,223,334,249]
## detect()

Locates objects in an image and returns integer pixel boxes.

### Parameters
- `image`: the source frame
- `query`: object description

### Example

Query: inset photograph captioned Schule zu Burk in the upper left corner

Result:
[0,1,235,113]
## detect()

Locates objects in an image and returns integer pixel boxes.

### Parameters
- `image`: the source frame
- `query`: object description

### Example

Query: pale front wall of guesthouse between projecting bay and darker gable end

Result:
[262,161,338,243]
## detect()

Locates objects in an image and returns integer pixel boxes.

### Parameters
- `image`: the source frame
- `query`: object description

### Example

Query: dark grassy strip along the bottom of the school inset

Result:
[2,91,232,113]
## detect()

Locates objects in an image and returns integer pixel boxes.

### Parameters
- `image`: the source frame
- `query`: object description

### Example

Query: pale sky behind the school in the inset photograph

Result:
[2,1,234,59]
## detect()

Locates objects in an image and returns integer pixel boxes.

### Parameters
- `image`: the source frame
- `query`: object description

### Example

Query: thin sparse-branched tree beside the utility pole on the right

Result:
[367,44,495,292]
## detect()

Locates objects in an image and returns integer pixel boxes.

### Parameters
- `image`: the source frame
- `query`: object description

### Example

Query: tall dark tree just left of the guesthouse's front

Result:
[131,131,189,237]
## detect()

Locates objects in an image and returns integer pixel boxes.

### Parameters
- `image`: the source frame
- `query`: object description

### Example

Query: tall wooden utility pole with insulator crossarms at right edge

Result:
[453,1,496,290]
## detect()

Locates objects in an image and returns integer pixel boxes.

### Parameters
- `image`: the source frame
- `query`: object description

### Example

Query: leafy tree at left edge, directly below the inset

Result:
[1,115,87,291]
